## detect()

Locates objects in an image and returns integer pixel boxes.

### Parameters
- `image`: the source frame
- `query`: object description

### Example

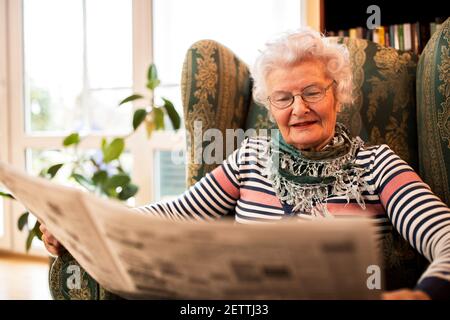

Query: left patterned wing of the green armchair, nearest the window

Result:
[181,40,252,186]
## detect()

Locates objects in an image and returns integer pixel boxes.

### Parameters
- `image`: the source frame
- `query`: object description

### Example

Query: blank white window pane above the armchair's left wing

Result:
[153,0,301,83]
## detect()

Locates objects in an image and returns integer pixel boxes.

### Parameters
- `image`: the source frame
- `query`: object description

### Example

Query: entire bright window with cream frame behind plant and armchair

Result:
[0,0,303,252]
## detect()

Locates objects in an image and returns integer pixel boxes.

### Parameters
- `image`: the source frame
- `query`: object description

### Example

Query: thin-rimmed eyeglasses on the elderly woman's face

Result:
[267,80,336,109]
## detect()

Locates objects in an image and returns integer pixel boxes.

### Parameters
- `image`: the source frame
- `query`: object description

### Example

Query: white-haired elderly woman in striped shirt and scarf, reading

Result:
[42,29,450,299]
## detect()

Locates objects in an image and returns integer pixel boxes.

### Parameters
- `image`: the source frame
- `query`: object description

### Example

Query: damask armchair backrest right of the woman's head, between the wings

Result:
[331,38,419,169]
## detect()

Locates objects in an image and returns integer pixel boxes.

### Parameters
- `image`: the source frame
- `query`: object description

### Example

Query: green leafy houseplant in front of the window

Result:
[0,64,181,251]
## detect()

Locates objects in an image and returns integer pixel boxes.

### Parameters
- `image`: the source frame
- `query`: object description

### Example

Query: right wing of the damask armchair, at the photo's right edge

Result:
[417,18,450,206]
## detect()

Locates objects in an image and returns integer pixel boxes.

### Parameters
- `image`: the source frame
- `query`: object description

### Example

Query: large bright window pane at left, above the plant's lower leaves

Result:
[23,0,132,133]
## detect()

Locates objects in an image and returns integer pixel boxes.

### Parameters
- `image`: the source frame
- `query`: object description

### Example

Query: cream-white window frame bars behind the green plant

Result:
[0,0,169,255]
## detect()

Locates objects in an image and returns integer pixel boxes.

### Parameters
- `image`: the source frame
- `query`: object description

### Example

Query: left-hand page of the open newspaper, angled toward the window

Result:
[0,162,132,290]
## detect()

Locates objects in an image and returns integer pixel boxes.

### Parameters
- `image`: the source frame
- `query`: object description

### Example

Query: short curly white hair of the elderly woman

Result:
[252,28,353,108]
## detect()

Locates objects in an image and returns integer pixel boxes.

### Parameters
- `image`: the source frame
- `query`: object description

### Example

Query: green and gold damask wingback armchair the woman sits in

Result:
[49,19,450,299]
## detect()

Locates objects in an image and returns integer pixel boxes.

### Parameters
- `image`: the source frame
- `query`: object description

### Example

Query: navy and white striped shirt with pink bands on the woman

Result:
[139,137,450,298]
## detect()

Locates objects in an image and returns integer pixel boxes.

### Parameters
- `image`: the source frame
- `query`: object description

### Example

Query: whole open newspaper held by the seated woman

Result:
[0,163,380,299]
